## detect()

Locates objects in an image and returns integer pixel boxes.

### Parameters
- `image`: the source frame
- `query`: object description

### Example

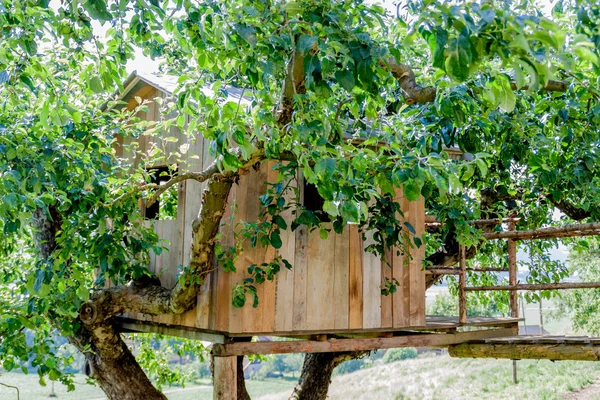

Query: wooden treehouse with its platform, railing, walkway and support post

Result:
[109,73,600,399]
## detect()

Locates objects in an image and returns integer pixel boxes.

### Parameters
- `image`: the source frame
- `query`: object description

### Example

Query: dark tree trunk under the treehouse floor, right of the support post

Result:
[290,351,369,400]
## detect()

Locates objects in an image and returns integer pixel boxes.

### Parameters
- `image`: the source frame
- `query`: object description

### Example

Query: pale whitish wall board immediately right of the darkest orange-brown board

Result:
[363,232,381,329]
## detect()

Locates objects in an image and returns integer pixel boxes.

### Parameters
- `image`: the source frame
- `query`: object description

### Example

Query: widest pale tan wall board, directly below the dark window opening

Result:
[306,230,335,330]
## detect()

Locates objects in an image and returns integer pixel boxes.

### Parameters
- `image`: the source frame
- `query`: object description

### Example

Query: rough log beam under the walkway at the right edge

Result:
[448,343,600,361]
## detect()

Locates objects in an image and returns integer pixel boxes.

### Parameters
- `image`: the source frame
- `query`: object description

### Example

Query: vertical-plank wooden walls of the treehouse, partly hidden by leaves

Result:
[120,86,425,336]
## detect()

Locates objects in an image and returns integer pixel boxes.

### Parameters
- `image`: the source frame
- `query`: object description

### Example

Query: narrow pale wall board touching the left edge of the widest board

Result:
[292,226,308,331]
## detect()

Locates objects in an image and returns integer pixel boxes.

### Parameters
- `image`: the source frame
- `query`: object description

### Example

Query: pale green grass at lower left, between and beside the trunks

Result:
[0,373,296,400]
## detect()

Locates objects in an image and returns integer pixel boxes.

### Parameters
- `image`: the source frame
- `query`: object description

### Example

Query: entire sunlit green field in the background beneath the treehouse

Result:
[0,355,600,400]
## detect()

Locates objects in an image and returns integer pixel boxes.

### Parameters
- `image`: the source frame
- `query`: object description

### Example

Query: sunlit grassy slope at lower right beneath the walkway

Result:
[255,355,600,400]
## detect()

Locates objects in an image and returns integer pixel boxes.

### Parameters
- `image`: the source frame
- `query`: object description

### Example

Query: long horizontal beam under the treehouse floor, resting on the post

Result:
[212,324,517,359]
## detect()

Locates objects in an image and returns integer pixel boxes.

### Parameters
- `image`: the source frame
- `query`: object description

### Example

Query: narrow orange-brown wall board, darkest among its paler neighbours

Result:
[348,225,363,329]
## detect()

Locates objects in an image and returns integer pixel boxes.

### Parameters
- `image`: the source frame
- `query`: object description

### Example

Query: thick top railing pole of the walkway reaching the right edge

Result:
[482,222,600,240]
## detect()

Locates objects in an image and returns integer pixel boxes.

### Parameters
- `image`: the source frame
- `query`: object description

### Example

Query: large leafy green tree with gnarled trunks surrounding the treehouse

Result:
[0,0,600,399]
